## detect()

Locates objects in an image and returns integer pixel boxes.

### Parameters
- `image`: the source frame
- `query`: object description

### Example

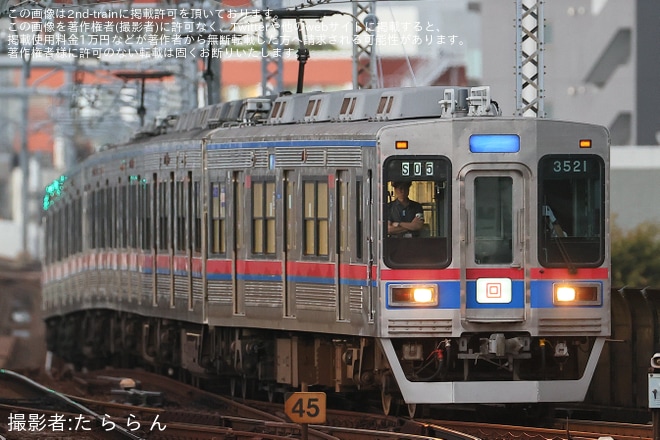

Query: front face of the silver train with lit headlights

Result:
[378,98,610,410]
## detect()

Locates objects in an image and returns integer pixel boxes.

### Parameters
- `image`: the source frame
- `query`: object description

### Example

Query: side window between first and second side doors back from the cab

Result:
[303,180,329,256]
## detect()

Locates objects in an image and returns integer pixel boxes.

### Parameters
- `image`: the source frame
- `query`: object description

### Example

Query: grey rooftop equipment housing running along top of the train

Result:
[126,86,500,143]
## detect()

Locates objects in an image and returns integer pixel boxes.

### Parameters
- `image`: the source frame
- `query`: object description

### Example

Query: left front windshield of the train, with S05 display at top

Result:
[383,156,451,268]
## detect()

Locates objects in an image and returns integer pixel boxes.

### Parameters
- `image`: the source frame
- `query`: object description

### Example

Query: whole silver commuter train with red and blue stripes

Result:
[42,86,612,414]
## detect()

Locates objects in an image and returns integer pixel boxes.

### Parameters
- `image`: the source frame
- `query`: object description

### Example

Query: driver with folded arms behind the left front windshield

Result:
[387,182,424,237]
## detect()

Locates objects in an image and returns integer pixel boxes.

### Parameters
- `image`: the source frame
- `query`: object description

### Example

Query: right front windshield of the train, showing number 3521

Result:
[539,154,605,269]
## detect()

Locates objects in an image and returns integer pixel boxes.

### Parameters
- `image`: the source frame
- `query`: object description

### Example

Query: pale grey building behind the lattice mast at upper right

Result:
[480,0,660,145]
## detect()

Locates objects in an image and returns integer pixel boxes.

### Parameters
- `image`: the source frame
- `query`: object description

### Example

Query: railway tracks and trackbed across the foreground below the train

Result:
[0,370,652,440]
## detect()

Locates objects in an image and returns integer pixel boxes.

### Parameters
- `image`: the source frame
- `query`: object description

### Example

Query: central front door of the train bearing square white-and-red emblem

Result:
[460,169,526,322]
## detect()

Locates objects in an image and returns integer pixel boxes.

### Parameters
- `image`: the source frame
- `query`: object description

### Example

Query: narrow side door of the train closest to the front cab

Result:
[335,171,353,321]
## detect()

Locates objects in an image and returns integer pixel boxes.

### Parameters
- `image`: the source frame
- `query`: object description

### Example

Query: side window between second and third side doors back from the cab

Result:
[252,181,275,254]
